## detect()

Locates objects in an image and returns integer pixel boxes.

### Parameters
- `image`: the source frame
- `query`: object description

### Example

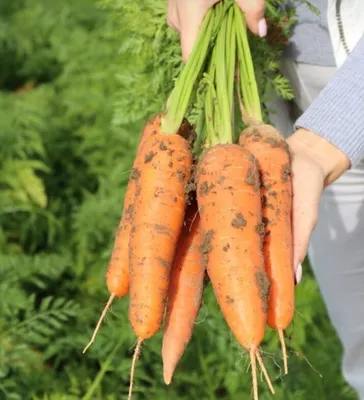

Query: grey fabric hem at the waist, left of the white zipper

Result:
[284,0,335,67]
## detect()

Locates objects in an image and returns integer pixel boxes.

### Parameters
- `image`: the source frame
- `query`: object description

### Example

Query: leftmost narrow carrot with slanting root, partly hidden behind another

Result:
[83,114,161,353]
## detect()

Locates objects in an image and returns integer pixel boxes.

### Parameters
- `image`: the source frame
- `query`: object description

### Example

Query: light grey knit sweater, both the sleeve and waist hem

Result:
[285,0,364,167]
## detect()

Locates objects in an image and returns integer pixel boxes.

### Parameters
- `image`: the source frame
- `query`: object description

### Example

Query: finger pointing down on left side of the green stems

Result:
[178,0,220,62]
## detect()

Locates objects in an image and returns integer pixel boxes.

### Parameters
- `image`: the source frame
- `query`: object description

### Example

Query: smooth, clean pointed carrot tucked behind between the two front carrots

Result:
[162,201,205,385]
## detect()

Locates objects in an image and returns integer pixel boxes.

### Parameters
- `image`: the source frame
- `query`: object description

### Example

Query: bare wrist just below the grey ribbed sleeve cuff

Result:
[287,128,350,186]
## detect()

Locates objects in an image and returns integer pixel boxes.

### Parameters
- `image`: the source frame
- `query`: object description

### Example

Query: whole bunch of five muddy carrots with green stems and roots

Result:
[84,0,294,400]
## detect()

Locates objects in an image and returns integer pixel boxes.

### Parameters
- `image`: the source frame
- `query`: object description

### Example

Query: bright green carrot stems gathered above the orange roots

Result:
[161,0,263,148]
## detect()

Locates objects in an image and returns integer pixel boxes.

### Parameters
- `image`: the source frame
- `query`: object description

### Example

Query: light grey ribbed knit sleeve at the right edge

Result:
[295,36,364,166]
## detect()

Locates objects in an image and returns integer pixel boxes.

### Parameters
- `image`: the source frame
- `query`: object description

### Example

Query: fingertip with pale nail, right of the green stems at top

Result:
[236,0,267,37]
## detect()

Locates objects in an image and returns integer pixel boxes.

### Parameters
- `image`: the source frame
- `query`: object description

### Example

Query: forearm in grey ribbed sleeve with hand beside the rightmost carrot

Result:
[287,37,364,283]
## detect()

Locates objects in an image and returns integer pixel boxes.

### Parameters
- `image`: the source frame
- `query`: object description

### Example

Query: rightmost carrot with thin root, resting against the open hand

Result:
[239,124,294,373]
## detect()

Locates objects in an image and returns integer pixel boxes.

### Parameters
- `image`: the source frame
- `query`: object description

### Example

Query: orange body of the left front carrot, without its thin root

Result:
[129,122,192,340]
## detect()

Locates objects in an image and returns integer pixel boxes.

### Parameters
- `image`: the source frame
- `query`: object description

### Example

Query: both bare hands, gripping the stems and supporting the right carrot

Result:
[168,0,349,284]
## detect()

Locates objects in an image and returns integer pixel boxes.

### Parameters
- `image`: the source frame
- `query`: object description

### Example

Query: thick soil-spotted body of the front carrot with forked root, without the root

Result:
[196,144,269,351]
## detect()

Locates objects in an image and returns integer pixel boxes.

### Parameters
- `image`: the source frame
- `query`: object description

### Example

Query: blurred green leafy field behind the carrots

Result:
[0,0,355,400]
